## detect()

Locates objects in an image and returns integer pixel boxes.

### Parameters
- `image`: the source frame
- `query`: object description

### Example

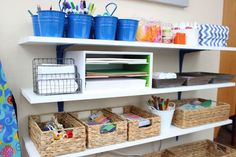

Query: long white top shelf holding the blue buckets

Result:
[19,36,236,51]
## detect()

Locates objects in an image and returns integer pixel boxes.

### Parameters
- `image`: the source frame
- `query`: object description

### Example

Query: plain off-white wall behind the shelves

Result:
[0,0,223,156]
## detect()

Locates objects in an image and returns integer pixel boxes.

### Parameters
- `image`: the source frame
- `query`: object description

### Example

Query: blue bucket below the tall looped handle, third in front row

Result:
[94,16,118,40]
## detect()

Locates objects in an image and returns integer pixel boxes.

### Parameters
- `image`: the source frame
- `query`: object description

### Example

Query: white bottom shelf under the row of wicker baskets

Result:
[23,120,232,157]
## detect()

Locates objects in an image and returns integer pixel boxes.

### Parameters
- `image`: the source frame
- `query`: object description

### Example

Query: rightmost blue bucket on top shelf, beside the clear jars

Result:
[117,19,138,41]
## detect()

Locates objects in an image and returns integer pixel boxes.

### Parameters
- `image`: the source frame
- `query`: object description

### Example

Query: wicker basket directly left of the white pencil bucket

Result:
[108,106,160,141]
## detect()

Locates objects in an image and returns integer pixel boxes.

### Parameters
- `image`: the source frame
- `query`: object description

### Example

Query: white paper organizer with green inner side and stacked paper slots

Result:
[65,51,153,91]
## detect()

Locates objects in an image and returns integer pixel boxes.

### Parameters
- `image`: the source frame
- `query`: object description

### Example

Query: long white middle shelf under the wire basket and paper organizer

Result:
[21,82,235,104]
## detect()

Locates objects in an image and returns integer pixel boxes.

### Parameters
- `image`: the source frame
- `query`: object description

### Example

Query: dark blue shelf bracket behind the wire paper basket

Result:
[56,45,71,112]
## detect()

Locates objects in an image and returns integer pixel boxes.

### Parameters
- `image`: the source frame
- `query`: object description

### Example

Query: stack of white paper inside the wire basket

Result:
[37,64,78,94]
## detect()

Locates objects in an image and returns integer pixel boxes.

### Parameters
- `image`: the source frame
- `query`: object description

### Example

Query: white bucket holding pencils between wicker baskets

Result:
[148,106,175,133]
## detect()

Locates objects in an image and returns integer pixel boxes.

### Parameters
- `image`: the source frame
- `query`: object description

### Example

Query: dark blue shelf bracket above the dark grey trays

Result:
[178,49,201,100]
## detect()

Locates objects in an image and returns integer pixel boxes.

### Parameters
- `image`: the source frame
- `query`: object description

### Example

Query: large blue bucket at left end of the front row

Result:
[38,10,65,37]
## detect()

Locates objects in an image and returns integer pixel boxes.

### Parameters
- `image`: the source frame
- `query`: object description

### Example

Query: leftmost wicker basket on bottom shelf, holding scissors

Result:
[29,113,86,157]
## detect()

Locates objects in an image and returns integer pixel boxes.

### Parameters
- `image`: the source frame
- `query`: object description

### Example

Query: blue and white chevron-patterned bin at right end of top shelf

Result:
[199,24,229,47]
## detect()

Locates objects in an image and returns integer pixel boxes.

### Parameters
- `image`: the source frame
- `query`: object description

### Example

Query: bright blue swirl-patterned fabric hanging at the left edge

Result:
[0,62,21,157]
